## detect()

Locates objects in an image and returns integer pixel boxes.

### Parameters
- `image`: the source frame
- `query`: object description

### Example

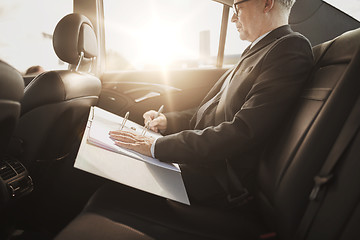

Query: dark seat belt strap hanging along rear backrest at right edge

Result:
[295,98,360,239]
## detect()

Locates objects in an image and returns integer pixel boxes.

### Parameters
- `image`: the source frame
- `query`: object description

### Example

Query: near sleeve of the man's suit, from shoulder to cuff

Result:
[155,36,313,164]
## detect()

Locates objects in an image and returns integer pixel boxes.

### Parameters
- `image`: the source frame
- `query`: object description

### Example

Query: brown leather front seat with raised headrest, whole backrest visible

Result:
[15,13,101,162]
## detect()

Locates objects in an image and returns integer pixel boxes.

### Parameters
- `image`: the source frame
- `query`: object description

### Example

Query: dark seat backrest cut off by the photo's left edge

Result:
[0,60,24,155]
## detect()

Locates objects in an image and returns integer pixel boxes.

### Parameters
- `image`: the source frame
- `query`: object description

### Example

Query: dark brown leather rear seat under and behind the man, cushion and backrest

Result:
[56,29,360,240]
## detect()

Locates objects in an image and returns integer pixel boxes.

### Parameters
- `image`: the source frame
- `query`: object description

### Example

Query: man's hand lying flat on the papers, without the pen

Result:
[109,130,154,157]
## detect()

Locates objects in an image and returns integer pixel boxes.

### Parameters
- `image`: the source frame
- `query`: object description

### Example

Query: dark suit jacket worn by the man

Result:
[155,25,313,171]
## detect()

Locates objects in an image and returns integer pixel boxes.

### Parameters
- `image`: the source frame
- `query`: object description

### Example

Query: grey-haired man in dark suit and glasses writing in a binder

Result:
[110,0,313,205]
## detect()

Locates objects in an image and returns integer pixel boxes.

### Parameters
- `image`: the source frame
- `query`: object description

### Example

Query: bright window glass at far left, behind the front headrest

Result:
[0,0,73,72]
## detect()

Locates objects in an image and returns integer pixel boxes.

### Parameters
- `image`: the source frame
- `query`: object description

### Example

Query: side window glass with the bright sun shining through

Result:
[104,0,223,71]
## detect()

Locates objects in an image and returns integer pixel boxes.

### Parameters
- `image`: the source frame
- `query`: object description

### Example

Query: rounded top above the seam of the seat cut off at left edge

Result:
[0,60,24,102]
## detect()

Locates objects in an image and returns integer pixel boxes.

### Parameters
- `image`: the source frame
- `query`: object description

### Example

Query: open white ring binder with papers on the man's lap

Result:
[74,107,190,205]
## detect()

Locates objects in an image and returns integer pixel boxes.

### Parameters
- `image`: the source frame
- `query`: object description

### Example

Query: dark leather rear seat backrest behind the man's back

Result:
[257,29,360,239]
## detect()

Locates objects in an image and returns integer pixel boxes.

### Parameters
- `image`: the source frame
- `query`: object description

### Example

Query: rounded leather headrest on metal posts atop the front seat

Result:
[53,13,98,65]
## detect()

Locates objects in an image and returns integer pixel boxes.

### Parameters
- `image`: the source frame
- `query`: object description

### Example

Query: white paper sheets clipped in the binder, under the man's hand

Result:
[87,107,180,172]
